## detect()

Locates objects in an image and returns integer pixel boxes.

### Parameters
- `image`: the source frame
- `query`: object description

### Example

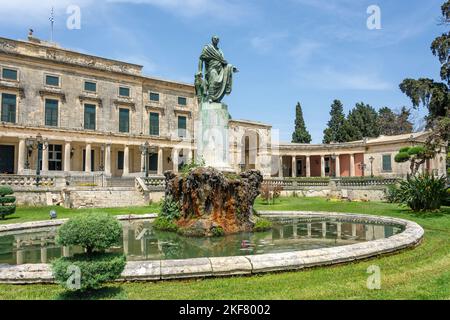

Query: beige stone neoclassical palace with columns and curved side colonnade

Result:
[0,36,446,181]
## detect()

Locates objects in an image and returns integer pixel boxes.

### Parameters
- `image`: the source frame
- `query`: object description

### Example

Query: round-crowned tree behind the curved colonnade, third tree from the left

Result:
[345,102,380,141]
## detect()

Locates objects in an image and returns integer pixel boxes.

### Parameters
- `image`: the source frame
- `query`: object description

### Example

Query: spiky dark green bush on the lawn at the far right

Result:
[398,173,447,212]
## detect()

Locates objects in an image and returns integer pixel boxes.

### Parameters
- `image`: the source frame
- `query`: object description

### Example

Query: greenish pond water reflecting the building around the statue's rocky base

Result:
[0,217,403,265]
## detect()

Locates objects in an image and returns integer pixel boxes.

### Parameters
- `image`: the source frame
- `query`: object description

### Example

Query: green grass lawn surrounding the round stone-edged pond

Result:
[0,198,450,299]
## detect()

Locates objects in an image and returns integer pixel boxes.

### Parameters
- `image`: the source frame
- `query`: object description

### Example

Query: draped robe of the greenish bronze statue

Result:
[200,44,233,102]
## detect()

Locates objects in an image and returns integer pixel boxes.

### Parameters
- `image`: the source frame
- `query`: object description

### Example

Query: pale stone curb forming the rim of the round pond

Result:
[0,211,424,284]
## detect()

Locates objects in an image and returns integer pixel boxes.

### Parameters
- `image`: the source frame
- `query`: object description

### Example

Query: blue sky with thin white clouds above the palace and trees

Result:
[0,0,445,143]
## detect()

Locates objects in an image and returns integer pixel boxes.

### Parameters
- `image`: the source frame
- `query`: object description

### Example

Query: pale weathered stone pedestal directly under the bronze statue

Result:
[197,102,234,172]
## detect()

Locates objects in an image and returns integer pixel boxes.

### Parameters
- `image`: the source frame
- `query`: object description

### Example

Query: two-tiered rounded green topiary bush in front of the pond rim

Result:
[52,213,126,291]
